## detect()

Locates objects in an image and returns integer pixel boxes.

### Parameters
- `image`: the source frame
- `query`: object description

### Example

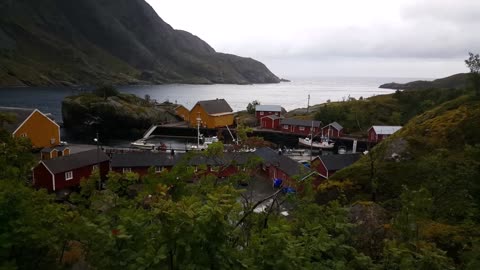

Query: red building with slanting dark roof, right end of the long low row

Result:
[255,147,316,186]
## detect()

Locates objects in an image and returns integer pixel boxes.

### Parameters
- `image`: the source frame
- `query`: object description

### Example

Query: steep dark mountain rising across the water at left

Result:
[0,0,279,86]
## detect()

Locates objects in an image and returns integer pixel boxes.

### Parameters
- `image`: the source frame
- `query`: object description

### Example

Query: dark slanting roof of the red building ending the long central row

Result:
[255,147,311,176]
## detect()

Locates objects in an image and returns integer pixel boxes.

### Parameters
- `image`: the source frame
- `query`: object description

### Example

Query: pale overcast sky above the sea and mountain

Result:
[147,0,480,78]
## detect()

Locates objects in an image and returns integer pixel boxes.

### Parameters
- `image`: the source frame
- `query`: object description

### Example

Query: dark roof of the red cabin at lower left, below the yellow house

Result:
[41,149,110,173]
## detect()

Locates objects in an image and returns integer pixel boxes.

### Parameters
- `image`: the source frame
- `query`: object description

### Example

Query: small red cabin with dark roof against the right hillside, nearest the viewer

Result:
[312,153,361,179]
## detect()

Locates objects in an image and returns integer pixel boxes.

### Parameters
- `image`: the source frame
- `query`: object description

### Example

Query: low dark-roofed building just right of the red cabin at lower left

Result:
[110,151,183,177]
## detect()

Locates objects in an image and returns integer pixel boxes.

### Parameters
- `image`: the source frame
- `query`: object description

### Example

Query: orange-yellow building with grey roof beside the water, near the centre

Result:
[189,99,233,128]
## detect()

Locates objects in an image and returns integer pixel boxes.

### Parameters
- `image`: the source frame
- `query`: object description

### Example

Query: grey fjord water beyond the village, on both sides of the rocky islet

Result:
[0,77,416,122]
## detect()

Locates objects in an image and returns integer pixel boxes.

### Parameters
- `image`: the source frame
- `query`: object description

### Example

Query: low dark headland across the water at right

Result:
[380,73,468,90]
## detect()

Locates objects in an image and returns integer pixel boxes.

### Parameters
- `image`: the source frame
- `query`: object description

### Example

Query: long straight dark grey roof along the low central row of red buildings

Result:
[111,152,253,168]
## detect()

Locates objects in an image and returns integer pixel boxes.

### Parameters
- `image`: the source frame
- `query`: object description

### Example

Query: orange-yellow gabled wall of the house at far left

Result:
[13,110,60,148]
